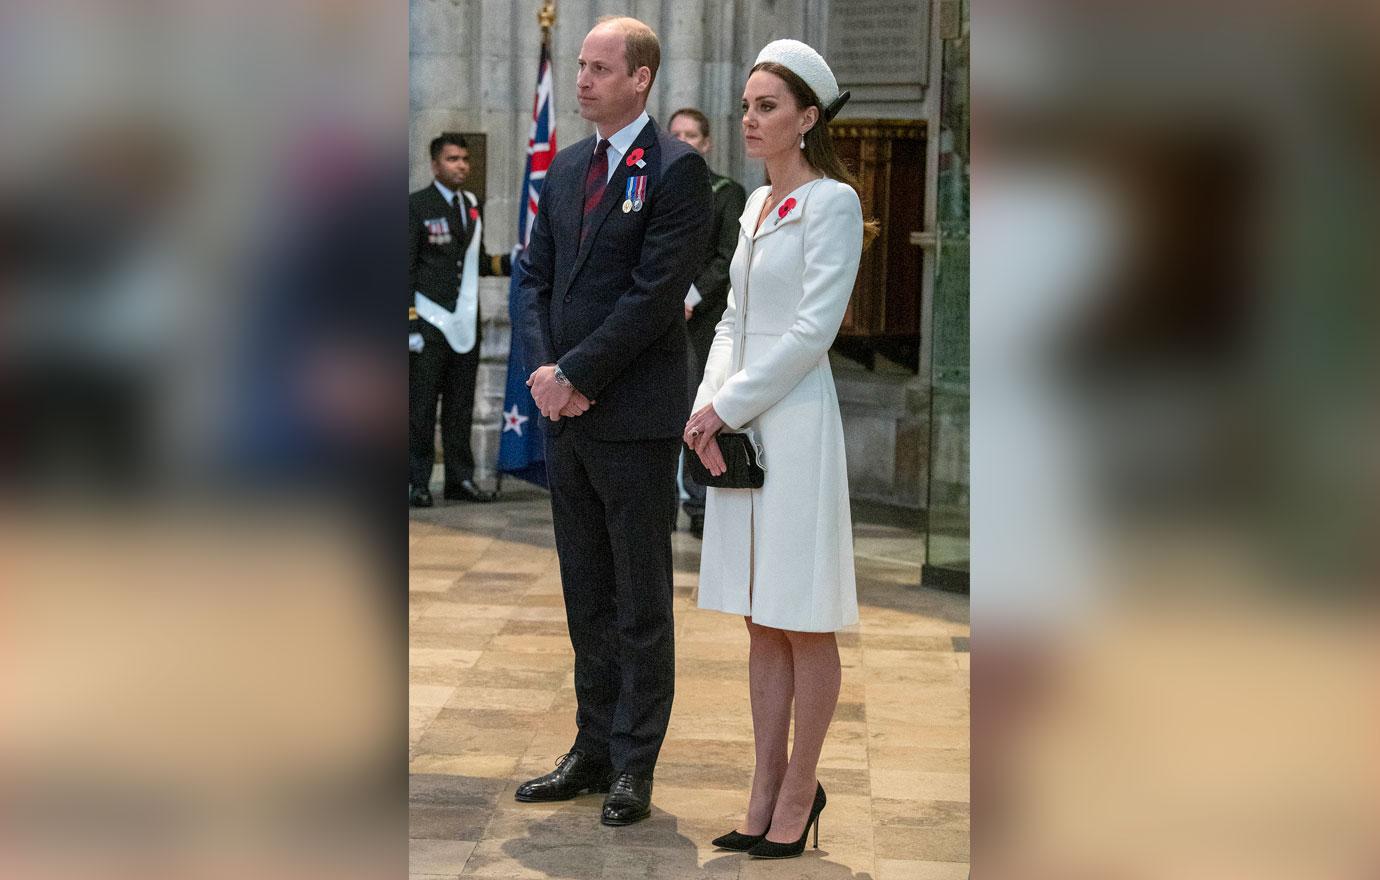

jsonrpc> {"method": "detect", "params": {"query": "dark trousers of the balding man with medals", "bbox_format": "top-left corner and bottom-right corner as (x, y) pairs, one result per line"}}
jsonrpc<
(546, 430), (679, 775)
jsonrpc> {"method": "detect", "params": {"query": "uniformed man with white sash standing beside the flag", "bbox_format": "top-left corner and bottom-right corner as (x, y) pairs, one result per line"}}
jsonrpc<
(407, 134), (512, 508)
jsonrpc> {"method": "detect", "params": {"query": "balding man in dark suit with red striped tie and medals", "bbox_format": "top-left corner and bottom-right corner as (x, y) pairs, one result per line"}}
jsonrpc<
(515, 18), (712, 825)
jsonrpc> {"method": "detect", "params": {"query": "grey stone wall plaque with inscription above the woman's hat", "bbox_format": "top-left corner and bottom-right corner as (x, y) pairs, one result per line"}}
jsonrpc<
(825, 0), (930, 88)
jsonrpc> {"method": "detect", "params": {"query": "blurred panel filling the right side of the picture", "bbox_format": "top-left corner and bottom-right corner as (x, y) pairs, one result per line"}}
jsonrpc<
(972, 3), (1380, 880)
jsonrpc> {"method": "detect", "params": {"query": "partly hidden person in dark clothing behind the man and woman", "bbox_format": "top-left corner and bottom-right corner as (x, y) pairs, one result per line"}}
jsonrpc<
(667, 108), (748, 538)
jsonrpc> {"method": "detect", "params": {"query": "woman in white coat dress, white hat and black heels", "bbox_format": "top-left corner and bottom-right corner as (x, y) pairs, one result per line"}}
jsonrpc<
(684, 40), (875, 858)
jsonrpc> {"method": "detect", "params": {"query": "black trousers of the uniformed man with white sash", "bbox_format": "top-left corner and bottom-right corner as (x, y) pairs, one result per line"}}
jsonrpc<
(407, 321), (479, 488)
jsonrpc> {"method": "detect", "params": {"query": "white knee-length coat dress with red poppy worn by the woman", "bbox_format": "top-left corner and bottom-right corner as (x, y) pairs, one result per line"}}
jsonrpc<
(694, 178), (863, 632)
